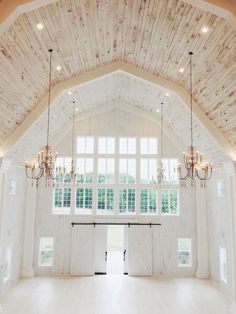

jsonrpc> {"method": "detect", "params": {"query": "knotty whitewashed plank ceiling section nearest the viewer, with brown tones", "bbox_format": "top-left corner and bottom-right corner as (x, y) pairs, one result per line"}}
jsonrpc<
(0, 0), (236, 162)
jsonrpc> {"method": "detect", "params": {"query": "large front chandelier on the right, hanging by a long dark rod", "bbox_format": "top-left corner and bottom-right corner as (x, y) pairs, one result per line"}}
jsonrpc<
(177, 51), (212, 187)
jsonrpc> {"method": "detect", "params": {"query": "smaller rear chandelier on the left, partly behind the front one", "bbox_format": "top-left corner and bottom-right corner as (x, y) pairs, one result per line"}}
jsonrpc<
(56, 101), (77, 186)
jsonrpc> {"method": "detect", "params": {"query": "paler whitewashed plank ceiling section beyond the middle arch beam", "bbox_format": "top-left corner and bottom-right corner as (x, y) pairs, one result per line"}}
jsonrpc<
(7, 71), (230, 165)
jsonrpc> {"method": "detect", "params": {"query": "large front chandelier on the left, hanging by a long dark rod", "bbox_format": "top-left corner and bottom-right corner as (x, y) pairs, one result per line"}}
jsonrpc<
(25, 49), (57, 187)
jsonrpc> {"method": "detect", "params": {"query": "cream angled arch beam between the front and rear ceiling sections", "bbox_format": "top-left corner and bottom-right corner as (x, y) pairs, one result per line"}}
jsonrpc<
(0, 62), (236, 160)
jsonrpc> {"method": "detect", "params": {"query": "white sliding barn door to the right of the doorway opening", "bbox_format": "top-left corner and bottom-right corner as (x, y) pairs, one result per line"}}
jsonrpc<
(128, 226), (152, 276)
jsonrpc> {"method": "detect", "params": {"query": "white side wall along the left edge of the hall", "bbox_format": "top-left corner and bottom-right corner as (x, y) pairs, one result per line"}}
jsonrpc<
(0, 166), (25, 294)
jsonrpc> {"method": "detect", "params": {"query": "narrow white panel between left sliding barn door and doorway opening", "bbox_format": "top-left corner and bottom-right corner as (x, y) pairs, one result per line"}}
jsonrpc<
(94, 225), (107, 274)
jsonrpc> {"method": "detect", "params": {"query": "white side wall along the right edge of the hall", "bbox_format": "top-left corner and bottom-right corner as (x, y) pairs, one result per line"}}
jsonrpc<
(207, 168), (235, 293)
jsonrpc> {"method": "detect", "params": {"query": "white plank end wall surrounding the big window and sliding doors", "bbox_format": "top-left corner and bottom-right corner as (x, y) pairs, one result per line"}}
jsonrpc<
(34, 109), (197, 276)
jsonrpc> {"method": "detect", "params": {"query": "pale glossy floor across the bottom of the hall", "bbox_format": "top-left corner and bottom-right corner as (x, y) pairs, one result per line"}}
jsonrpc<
(0, 275), (229, 314)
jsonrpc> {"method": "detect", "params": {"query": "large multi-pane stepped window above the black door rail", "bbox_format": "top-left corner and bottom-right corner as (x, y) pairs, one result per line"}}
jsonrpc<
(53, 136), (179, 215)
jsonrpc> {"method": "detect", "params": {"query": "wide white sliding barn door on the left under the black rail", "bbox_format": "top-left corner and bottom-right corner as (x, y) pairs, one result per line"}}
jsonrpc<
(71, 225), (95, 275)
